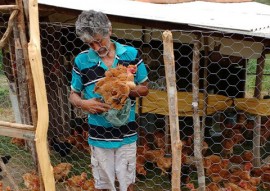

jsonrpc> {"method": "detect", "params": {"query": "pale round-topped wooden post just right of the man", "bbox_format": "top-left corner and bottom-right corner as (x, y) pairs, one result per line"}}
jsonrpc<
(162, 31), (182, 191)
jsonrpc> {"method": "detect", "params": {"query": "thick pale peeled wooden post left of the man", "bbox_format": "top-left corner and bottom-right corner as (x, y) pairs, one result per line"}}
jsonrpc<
(28, 0), (55, 191)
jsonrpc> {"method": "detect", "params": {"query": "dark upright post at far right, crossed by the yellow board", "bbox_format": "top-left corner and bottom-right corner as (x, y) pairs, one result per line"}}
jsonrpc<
(253, 50), (265, 167)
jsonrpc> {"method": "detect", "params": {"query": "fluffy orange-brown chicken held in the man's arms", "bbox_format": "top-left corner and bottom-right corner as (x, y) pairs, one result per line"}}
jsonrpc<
(94, 65), (137, 110)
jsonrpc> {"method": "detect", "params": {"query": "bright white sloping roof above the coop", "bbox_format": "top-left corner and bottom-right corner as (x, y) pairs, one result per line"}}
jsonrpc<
(39, 0), (270, 38)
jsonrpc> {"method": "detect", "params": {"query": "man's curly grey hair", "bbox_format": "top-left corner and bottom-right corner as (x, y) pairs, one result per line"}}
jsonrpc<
(75, 10), (111, 42)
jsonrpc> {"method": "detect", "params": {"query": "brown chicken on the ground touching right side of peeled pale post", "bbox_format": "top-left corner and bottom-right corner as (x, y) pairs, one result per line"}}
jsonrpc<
(53, 163), (73, 182)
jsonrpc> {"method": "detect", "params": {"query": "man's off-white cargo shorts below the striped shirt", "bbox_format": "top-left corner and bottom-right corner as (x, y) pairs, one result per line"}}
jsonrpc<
(91, 142), (137, 191)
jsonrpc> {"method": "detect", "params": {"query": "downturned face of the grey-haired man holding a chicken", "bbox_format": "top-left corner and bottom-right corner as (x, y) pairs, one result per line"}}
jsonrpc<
(88, 34), (111, 58)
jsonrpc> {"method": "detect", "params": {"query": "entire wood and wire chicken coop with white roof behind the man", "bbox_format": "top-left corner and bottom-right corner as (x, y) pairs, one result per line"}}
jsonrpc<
(0, 0), (270, 191)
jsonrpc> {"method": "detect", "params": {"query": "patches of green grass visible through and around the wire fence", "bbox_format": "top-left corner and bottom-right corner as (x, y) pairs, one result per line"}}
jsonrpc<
(0, 56), (270, 191)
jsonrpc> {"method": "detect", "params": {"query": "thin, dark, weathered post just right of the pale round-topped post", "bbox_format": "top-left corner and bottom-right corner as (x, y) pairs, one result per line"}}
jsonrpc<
(192, 37), (205, 191)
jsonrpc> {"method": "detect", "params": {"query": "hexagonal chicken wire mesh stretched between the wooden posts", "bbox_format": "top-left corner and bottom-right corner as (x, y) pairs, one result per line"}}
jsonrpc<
(0, 13), (270, 191)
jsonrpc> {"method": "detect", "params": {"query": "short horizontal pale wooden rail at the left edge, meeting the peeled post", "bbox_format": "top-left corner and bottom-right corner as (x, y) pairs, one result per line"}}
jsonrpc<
(0, 125), (35, 141)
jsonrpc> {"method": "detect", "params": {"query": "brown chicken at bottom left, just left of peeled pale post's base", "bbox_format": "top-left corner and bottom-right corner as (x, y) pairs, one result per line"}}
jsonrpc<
(22, 172), (40, 191)
